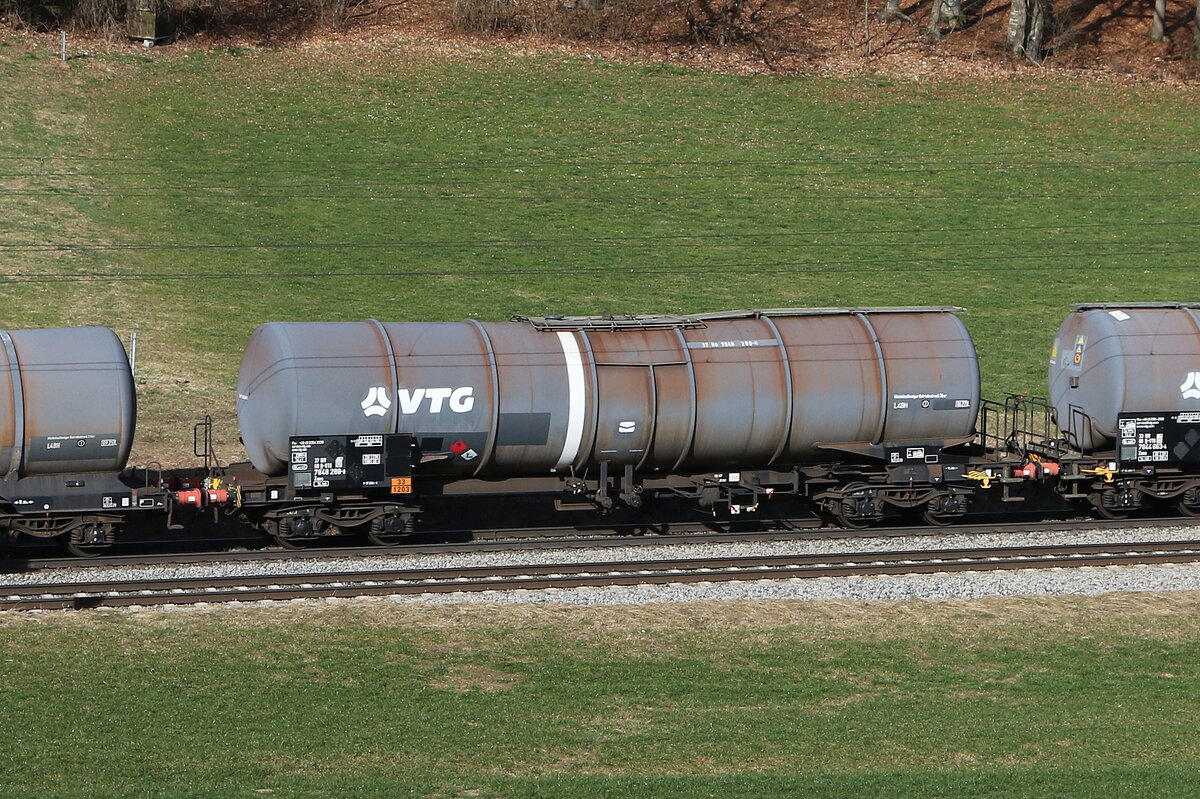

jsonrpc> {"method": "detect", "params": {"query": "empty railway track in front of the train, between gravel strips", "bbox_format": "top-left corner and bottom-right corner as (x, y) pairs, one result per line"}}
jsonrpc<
(9, 541), (1200, 611)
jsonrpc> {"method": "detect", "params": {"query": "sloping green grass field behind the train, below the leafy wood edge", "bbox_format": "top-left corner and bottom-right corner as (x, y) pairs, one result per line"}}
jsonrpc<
(0, 34), (1200, 455)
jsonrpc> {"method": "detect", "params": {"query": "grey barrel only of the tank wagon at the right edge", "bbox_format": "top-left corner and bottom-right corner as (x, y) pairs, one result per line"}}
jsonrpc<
(1048, 302), (1200, 452)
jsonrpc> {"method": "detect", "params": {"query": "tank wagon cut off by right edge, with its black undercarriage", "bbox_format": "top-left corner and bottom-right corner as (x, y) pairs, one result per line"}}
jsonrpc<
(1048, 302), (1200, 517)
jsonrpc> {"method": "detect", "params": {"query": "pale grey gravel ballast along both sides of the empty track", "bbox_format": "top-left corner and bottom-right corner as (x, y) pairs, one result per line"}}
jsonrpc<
(7, 525), (1200, 605)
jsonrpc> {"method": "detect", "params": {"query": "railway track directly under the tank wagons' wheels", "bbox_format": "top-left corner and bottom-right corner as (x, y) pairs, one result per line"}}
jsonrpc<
(0, 517), (1194, 573)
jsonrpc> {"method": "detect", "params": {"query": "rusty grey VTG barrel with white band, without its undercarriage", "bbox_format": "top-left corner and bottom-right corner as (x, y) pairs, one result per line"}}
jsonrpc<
(238, 308), (979, 477)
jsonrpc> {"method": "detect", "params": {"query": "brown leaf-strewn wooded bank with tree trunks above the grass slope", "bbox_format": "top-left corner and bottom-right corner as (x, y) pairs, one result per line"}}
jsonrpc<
(7, 0), (1200, 82)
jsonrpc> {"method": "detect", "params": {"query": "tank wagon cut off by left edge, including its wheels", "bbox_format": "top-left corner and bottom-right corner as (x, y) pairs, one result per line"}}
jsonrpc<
(0, 328), (166, 553)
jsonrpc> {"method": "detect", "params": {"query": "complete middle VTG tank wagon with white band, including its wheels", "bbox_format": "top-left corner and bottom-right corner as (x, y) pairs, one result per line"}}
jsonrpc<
(229, 307), (979, 540)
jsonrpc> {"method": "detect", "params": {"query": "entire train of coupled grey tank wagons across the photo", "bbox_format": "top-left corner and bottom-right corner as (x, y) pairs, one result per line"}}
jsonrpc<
(11, 298), (1200, 554)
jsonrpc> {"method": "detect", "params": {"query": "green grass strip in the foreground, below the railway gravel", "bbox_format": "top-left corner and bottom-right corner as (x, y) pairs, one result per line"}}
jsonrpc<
(0, 597), (1200, 797)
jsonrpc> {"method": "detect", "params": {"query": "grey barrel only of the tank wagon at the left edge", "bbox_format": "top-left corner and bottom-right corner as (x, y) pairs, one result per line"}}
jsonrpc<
(0, 328), (137, 479)
